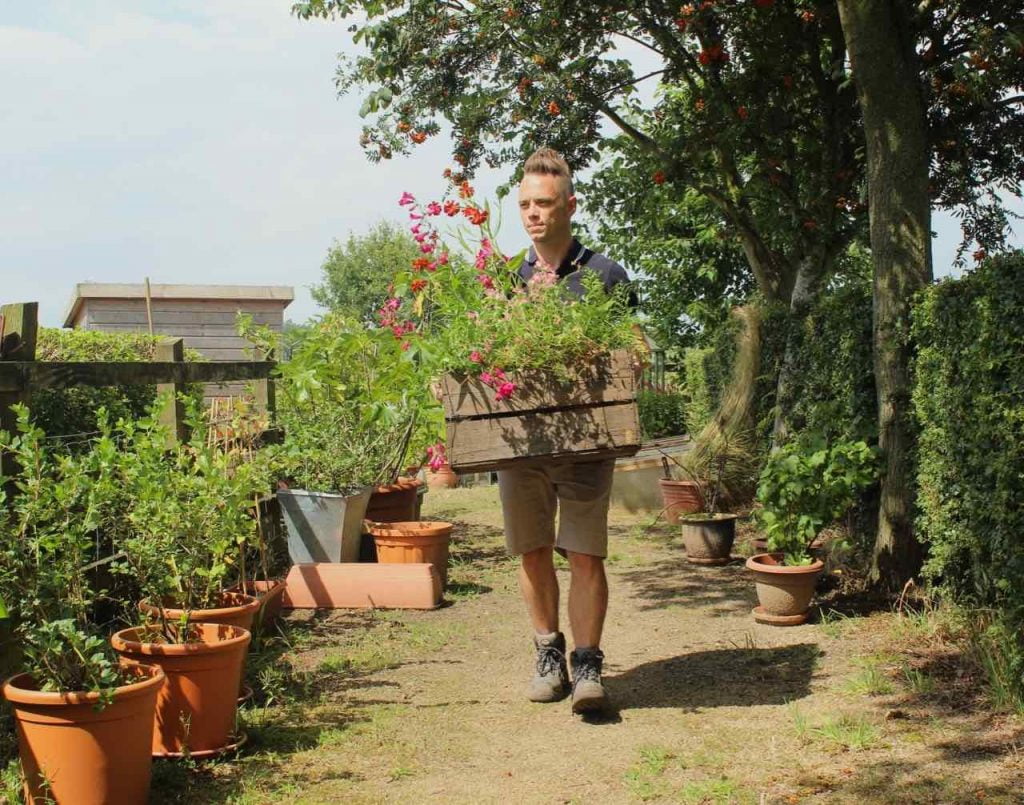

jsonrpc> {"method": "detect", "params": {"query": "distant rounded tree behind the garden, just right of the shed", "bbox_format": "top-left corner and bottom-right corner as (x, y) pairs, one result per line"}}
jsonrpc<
(310, 221), (420, 325)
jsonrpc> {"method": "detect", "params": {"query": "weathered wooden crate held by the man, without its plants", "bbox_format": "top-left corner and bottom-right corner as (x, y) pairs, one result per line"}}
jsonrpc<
(441, 350), (640, 472)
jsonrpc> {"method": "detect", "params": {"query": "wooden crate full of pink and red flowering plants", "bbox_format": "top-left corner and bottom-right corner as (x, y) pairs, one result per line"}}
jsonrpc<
(389, 189), (640, 471)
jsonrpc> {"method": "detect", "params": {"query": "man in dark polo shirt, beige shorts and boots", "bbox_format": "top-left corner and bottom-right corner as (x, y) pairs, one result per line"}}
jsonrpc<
(498, 149), (629, 713)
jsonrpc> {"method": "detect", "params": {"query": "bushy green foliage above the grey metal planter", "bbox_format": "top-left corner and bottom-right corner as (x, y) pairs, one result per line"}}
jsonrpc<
(243, 313), (443, 492)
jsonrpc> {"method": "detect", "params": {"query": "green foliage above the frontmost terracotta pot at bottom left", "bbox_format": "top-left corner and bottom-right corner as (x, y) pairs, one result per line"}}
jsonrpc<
(0, 406), (120, 701)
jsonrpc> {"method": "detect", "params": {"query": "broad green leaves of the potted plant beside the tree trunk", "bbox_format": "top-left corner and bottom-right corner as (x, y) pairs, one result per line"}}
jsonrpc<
(758, 434), (878, 565)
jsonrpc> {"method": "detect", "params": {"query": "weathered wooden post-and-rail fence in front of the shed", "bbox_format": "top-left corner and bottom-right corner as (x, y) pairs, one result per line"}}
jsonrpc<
(0, 302), (276, 475)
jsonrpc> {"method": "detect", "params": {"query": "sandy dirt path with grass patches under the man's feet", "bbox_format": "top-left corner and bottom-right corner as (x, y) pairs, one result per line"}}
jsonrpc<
(154, 488), (1024, 805)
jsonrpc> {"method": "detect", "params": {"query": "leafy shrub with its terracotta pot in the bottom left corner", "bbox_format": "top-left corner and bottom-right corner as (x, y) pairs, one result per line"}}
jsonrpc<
(0, 408), (165, 805)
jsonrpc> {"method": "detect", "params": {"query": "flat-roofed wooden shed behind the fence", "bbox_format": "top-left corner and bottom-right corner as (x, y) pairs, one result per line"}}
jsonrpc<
(65, 283), (295, 361)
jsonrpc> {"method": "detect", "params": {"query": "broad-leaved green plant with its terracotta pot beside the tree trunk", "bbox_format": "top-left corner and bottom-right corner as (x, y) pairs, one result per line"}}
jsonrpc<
(746, 435), (877, 626)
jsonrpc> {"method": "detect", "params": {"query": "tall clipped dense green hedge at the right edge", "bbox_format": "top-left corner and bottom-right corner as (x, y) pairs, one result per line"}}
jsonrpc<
(913, 247), (1024, 610)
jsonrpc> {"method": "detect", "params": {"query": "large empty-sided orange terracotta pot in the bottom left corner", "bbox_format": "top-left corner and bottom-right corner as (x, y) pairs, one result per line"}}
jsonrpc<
(3, 665), (165, 805)
